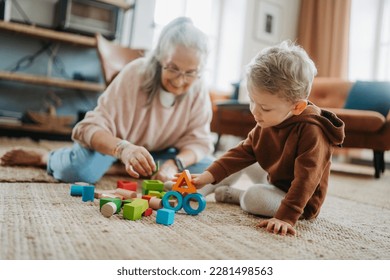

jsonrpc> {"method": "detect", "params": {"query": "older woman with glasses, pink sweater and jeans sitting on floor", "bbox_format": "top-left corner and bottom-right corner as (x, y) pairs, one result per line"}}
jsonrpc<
(1, 18), (213, 183)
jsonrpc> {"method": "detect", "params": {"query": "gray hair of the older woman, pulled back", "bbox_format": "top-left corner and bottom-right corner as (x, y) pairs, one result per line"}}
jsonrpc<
(142, 17), (209, 103)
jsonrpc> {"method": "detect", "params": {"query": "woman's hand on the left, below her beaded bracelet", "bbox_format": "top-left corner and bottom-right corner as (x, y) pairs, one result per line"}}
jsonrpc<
(120, 143), (156, 178)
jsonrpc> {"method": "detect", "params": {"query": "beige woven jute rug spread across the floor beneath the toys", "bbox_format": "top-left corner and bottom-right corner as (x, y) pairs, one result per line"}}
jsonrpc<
(0, 138), (390, 260)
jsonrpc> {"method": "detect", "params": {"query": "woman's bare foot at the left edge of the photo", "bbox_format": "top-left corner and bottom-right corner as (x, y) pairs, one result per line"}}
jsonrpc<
(1, 149), (49, 167)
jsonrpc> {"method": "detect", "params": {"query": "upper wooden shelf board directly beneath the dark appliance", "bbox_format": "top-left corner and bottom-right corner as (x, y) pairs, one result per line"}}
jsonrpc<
(0, 20), (96, 48)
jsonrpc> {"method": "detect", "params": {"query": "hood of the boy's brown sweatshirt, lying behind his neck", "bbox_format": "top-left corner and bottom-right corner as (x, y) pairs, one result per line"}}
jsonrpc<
(275, 102), (345, 146)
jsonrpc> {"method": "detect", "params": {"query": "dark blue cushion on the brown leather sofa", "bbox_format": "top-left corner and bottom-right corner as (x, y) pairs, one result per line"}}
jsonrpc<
(344, 81), (390, 117)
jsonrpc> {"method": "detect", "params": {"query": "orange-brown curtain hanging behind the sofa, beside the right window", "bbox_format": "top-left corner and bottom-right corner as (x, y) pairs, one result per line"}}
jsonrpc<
(298, 0), (351, 78)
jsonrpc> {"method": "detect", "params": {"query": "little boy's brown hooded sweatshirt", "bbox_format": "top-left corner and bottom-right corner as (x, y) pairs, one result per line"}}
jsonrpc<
(207, 102), (345, 225)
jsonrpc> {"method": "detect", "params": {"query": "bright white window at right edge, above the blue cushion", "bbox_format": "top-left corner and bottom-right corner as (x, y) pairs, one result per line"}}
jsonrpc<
(349, 0), (390, 81)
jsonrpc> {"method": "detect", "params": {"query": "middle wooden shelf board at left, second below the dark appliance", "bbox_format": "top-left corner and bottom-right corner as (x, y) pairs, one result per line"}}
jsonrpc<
(0, 70), (105, 92)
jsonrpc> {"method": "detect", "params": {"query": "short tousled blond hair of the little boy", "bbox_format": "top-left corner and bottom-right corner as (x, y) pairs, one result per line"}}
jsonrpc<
(246, 40), (317, 103)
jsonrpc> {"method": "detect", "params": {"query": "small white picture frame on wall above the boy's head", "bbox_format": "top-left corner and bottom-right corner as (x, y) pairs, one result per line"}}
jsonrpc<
(255, 0), (282, 44)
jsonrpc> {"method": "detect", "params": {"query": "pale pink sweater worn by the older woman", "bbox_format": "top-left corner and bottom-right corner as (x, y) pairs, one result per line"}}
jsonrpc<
(72, 58), (213, 160)
